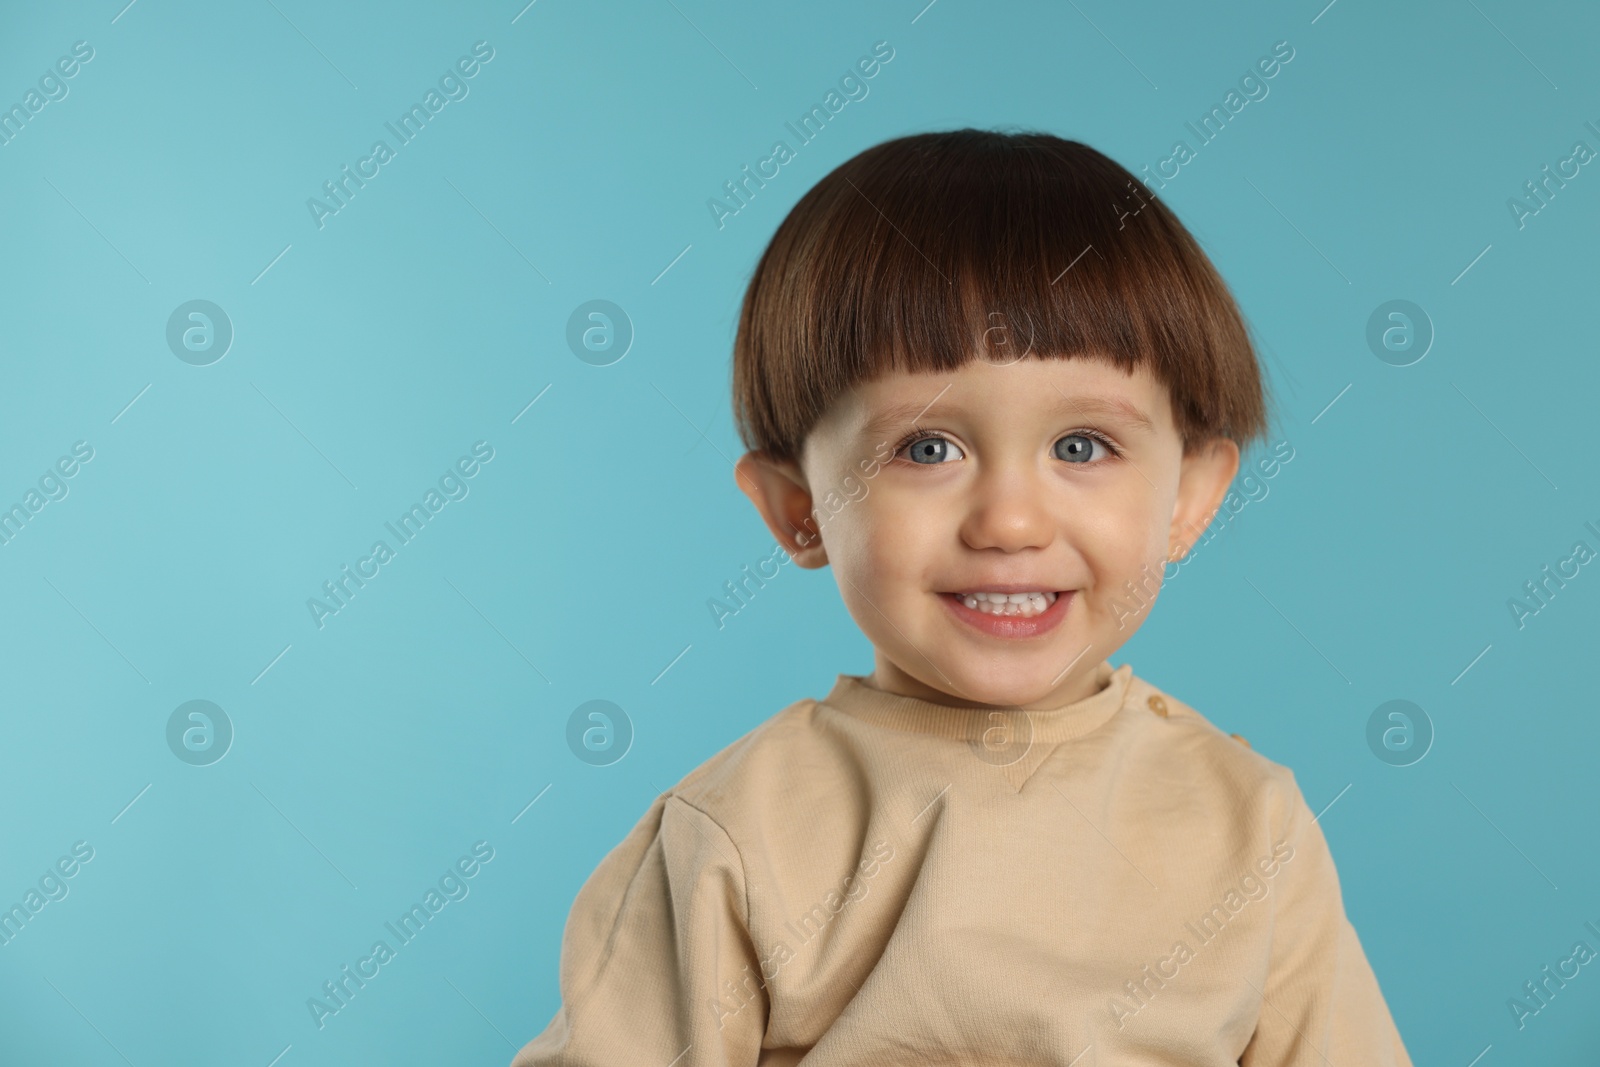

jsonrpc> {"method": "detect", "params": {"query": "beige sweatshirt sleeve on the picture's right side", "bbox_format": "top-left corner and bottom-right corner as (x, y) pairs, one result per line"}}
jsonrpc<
(1238, 773), (1411, 1067)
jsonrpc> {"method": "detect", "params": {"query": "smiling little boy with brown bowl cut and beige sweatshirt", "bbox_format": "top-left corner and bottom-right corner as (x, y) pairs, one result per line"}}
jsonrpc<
(514, 130), (1411, 1067)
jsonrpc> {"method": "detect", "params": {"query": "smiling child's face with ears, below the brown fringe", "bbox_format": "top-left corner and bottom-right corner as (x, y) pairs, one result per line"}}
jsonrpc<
(736, 358), (1238, 707)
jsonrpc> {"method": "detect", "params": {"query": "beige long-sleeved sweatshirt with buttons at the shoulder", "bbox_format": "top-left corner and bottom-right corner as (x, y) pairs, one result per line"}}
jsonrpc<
(512, 662), (1411, 1067)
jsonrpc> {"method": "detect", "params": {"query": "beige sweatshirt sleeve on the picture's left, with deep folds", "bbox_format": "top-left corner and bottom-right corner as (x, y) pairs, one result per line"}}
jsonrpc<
(512, 793), (766, 1067)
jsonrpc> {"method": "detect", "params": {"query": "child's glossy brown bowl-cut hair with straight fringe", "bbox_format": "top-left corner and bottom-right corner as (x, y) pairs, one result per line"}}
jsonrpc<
(733, 128), (1267, 461)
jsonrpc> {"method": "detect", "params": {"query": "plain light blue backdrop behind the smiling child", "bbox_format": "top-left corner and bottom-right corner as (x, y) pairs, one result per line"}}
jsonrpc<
(0, 0), (1600, 1067)
